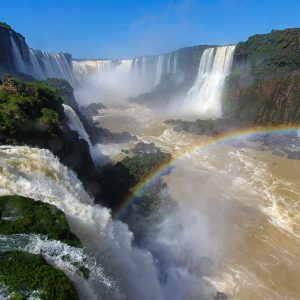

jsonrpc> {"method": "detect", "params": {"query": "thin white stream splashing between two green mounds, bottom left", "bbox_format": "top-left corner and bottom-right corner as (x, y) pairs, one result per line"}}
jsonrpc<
(0, 234), (109, 300)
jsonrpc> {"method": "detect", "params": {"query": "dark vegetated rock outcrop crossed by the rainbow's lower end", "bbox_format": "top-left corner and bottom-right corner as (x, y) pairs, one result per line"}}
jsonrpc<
(96, 151), (175, 243)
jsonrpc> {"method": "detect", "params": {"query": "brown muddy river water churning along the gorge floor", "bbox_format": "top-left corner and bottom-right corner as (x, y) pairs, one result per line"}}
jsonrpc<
(97, 107), (300, 300)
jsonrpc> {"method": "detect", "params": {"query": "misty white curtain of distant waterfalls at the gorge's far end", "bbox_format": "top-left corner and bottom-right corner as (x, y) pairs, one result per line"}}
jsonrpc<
(73, 46), (235, 119)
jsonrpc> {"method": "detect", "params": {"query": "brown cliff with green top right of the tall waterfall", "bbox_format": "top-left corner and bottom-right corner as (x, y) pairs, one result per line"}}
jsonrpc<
(223, 28), (300, 124)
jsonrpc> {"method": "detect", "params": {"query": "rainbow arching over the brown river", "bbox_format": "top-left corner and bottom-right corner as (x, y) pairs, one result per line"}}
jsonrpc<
(114, 125), (300, 218)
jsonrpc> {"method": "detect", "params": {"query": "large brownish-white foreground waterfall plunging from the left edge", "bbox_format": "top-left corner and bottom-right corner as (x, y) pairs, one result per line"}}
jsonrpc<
(0, 146), (163, 300)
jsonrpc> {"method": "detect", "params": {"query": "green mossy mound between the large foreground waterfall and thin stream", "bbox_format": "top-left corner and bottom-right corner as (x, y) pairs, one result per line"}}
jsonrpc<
(0, 195), (81, 247)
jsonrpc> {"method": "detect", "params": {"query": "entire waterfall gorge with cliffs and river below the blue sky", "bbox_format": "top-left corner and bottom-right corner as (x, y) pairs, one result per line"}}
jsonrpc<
(0, 19), (300, 300)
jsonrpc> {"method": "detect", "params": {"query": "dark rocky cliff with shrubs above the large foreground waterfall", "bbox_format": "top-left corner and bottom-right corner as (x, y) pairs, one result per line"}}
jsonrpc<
(0, 78), (94, 181)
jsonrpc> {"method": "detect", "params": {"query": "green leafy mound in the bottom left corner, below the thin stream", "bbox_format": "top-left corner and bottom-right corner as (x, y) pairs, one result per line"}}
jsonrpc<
(0, 251), (78, 300)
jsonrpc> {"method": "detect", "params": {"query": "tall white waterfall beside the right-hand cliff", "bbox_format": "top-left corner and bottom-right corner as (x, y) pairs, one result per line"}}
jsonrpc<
(185, 46), (235, 118)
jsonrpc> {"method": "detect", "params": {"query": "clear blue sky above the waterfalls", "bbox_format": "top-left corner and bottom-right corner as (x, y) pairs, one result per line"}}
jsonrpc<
(0, 0), (300, 58)
